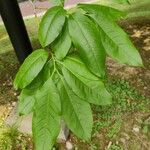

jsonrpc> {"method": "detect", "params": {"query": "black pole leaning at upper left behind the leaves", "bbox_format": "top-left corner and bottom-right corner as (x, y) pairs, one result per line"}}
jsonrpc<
(0, 0), (32, 63)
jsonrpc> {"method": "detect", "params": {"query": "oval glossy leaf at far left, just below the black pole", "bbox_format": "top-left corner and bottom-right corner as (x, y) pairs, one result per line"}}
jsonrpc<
(14, 49), (49, 89)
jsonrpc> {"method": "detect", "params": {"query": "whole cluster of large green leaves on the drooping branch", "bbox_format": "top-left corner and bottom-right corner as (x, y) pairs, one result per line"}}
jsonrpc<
(14, 1), (142, 150)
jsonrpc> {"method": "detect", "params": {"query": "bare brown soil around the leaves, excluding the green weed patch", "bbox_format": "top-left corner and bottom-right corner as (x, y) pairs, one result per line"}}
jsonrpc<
(0, 21), (150, 150)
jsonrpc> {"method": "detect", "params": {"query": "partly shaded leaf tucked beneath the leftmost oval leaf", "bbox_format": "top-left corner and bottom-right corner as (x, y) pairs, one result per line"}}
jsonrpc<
(18, 59), (57, 115)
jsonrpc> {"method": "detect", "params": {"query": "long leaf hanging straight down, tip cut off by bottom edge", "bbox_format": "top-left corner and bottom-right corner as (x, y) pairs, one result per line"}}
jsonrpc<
(32, 78), (61, 150)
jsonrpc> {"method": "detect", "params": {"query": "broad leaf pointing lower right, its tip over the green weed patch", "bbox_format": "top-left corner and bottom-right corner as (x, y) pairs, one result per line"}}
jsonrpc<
(63, 57), (112, 105)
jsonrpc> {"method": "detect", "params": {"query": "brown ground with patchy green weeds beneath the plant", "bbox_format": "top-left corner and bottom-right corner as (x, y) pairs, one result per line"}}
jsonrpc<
(0, 19), (150, 150)
